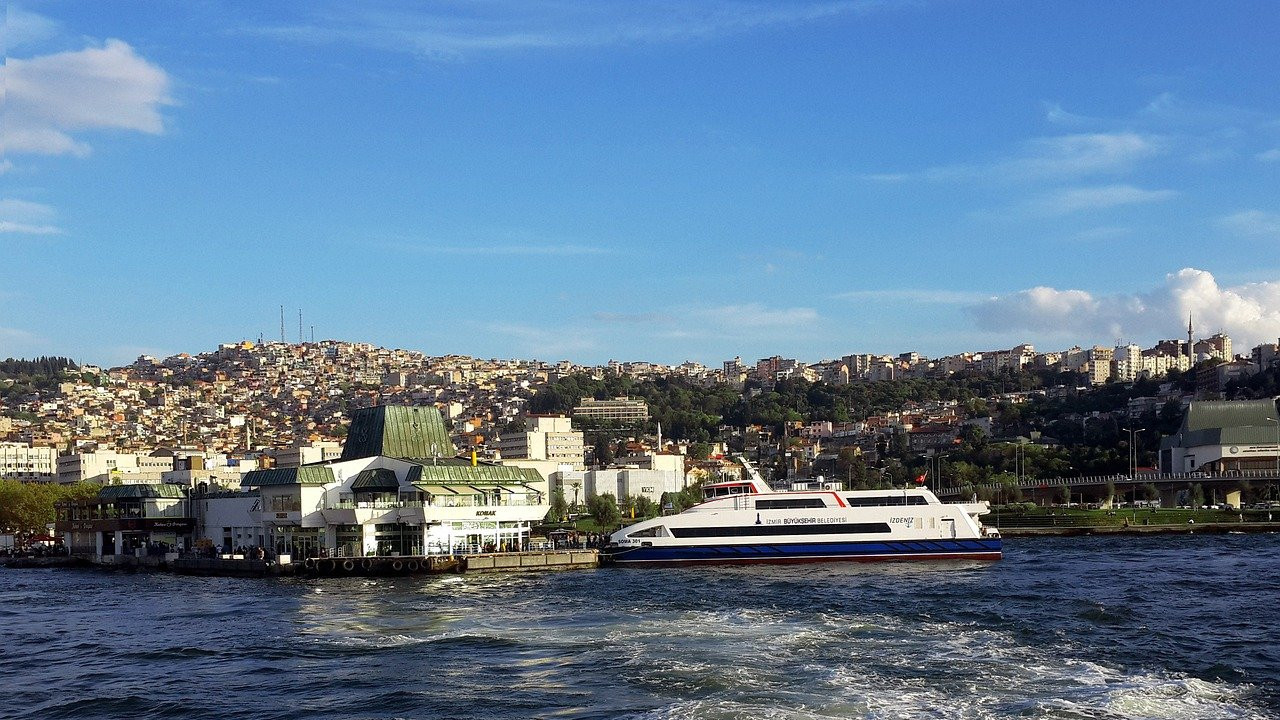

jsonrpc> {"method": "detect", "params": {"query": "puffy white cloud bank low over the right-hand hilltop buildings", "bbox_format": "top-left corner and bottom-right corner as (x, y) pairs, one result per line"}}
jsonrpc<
(968, 268), (1280, 348)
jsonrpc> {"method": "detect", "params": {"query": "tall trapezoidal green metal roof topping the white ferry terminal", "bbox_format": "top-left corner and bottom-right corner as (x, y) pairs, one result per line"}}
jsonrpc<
(342, 405), (457, 460)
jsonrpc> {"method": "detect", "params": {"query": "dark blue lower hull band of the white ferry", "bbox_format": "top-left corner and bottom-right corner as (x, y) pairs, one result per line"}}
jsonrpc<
(604, 538), (1001, 564)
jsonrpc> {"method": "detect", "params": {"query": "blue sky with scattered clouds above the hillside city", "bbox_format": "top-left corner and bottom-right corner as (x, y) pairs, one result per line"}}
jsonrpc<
(0, 0), (1280, 364)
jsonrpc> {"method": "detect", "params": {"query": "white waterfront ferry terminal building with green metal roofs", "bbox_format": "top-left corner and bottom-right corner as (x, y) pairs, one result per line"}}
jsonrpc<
(192, 406), (549, 560)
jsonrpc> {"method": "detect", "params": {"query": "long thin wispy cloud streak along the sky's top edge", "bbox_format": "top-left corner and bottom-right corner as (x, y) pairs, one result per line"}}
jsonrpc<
(246, 0), (890, 59)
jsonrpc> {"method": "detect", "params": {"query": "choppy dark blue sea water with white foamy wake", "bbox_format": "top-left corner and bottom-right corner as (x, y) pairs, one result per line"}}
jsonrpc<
(0, 536), (1280, 720)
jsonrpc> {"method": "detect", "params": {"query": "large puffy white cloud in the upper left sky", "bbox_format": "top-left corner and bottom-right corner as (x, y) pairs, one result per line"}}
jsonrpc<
(0, 40), (173, 156)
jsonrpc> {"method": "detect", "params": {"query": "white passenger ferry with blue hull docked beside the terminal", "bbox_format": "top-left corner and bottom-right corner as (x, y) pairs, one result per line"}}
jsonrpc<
(602, 462), (1001, 565)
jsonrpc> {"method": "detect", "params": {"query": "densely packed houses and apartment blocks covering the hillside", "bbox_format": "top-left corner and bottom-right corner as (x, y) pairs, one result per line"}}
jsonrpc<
(0, 324), (1277, 487)
